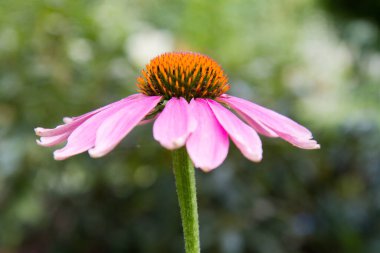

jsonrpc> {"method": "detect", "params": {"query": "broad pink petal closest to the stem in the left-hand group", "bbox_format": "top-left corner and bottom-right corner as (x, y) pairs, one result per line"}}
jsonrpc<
(89, 96), (161, 157)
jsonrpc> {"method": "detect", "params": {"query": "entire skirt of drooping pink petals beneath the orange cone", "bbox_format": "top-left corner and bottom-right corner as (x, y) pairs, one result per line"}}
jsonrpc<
(35, 94), (320, 171)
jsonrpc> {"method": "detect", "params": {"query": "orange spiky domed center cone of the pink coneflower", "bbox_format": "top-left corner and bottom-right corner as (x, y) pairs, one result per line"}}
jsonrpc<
(137, 52), (230, 101)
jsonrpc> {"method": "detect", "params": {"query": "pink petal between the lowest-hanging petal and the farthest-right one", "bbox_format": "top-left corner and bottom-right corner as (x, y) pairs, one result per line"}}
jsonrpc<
(207, 99), (263, 162)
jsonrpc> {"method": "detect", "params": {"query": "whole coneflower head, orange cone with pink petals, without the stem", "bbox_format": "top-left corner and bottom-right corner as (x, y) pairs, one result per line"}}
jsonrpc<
(35, 52), (320, 171)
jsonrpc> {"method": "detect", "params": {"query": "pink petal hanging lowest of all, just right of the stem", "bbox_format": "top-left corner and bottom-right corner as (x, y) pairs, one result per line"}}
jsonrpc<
(186, 98), (229, 171)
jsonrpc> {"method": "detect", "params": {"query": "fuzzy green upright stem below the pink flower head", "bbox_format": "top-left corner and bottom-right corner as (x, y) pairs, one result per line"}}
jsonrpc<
(172, 148), (200, 253)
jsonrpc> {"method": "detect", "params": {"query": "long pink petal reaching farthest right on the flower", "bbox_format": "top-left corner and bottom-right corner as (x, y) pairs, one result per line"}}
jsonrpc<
(219, 96), (320, 149)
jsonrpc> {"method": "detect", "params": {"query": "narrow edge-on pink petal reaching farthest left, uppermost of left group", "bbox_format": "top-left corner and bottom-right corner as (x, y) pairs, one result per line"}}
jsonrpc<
(34, 94), (143, 137)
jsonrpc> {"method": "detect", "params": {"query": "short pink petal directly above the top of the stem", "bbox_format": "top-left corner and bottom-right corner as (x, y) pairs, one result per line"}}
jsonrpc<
(153, 97), (196, 150)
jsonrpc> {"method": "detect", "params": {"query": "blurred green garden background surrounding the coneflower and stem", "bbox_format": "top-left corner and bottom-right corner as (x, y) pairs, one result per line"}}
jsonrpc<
(0, 0), (380, 253)
